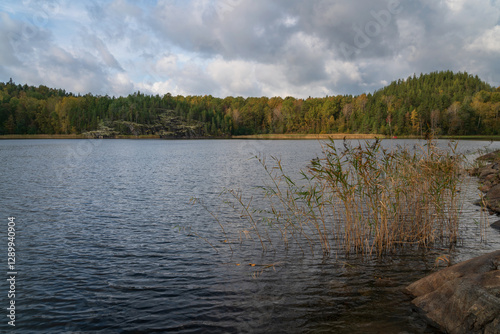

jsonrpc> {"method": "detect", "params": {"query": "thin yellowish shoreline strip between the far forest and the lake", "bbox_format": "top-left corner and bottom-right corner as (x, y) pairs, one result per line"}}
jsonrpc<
(0, 133), (500, 141)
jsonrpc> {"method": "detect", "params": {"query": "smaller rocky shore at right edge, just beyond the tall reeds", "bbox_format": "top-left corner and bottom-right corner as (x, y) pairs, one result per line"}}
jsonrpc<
(471, 151), (500, 214)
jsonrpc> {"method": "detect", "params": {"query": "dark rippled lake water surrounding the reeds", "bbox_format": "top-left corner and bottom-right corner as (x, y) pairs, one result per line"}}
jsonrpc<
(0, 140), (500, 333)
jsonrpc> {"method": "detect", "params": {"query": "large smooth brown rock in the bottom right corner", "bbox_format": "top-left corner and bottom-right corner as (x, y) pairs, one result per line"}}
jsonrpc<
(406, 250), (500, 334)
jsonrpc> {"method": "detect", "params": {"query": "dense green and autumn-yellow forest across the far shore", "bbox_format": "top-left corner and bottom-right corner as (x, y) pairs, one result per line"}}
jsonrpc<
(0, 71), (500, 137)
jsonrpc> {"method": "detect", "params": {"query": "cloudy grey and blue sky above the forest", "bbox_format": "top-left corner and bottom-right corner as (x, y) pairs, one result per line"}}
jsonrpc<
(0, 0), (500, 98)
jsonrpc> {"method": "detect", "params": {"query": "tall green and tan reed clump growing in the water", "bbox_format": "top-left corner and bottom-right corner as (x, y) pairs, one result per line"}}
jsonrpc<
(207, 140), (464, 256)
